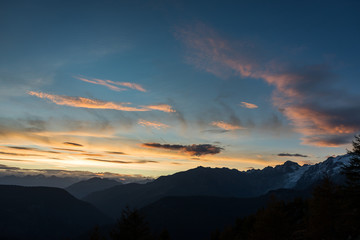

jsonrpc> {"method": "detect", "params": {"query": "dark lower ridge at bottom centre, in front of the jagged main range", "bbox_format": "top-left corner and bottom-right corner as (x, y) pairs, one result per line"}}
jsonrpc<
(140, 189), (310, 240)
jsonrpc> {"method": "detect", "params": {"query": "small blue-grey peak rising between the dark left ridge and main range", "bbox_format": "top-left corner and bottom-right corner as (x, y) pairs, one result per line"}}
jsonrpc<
(66, 177), (122, 198)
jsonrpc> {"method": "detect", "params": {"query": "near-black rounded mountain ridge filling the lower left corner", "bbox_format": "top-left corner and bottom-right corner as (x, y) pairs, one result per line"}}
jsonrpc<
(0, 185), (111, 240)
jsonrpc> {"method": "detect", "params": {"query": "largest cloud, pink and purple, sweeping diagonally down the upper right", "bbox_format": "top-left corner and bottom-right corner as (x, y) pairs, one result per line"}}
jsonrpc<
(177, 23), (360, 147)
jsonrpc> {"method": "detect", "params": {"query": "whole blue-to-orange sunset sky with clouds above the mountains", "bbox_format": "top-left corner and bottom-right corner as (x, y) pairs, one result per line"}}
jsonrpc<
(0, 0), (360, 177)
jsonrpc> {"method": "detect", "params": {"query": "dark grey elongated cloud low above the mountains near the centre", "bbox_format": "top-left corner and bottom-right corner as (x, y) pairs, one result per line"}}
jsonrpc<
(143, 143), (224, 156)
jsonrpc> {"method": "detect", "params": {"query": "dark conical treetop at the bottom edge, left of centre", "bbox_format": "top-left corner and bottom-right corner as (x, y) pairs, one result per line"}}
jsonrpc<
(110, 207), (154, 240)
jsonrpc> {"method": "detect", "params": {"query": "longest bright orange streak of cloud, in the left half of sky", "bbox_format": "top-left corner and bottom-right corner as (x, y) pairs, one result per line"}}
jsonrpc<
(28, 91), (175, 113)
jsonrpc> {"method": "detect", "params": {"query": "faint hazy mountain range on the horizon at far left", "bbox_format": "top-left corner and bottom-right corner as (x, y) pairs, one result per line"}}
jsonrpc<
(0, 174), (80, 188)
